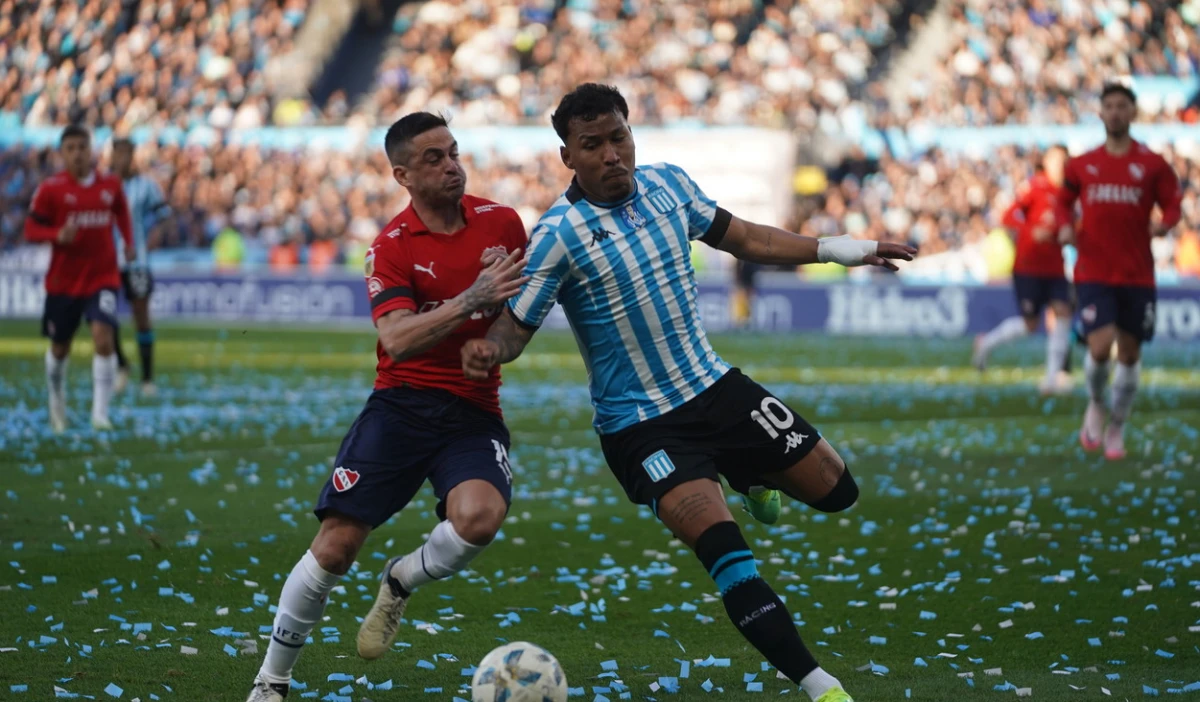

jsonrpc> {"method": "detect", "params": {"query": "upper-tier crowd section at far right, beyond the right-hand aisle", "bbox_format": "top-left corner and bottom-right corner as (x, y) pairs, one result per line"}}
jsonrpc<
(892, 0), (1200, 126)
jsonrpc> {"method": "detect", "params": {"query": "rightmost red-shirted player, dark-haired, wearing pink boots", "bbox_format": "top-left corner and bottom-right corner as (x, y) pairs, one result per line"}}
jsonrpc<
(1061, 84), (1183, 460)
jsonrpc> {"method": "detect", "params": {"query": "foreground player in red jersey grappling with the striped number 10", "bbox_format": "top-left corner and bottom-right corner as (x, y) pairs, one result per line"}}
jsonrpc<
(247, 113), (529, 702)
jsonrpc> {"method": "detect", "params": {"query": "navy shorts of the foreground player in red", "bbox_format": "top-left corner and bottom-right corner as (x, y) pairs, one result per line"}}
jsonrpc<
(313, 388), (512, 527)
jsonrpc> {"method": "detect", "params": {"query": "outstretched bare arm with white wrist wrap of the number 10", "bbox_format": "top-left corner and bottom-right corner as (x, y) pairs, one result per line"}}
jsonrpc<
(716, 217), (917, 270)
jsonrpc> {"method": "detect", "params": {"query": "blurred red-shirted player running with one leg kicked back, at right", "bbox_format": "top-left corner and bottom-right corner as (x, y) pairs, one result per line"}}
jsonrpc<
(972, 146), (1073, 395)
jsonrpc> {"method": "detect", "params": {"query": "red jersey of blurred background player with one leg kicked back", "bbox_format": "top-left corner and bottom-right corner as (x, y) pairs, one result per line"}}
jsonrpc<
(1004, 173), (1067, 278)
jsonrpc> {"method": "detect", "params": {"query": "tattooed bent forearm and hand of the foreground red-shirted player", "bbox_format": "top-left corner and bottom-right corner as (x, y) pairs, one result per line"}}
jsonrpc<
(376, 250), (529, 362)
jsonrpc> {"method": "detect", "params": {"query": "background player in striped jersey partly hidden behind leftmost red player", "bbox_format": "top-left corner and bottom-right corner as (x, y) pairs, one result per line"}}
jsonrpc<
(113, 139), (170, 397)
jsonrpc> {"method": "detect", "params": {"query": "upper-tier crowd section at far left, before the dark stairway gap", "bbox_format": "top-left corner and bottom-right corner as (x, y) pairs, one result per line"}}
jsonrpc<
(0, 0), (308, 130)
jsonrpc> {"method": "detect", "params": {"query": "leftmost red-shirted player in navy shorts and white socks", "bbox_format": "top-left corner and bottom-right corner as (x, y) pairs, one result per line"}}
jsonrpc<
(25, 125), (137, 433)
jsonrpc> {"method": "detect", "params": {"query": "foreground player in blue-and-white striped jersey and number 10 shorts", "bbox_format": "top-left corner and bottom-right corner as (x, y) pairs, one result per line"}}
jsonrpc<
(462, 84), (916, 702)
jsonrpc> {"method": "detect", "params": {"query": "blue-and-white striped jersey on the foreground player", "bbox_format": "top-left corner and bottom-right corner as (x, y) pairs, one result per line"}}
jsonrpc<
(509, 163), (731, 434)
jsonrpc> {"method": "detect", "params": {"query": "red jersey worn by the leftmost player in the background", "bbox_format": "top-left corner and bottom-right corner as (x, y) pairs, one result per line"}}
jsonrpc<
(25, 172), (133, 298)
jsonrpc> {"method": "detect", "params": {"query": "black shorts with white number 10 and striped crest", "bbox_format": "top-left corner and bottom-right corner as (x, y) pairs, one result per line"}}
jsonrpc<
(600, 368), (821, 509)
